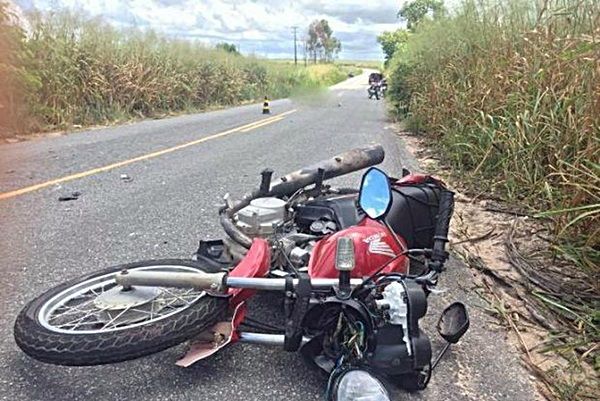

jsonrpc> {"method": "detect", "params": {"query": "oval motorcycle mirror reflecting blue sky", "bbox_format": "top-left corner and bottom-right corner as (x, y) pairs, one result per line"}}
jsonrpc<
(358, 168), (392, 219)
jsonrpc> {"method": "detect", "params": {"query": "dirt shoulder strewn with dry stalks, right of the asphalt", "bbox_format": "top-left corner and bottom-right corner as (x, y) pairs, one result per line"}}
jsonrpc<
(396, 126), (600, 400)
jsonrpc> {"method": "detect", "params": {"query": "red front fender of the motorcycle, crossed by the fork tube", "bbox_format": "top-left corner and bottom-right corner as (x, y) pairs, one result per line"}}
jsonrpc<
(229, 238), (271, 310)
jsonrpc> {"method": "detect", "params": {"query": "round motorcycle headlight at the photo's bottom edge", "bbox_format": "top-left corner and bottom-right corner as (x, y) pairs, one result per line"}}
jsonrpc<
(335, 370), (390, 401)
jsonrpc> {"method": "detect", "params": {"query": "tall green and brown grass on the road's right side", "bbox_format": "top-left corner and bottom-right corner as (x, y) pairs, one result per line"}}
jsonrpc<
(380, 0), (600, 399)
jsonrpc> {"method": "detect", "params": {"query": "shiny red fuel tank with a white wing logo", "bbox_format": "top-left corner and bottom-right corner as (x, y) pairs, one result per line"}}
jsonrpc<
(308, 218), (408, 278)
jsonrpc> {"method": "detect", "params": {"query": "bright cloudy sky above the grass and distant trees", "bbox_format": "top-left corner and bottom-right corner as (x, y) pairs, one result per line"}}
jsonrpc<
(14, 0), (403, 60)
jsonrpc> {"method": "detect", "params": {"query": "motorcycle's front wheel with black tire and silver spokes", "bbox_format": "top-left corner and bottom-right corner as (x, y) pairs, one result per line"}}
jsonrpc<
(14, 259), (228, 366)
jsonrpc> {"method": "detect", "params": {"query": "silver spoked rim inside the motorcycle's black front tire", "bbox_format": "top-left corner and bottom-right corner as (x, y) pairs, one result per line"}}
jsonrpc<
(37, 265), (205, 334)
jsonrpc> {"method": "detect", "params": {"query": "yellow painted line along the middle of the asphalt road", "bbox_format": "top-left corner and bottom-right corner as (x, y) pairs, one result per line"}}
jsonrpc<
(0, 109), (297, 200)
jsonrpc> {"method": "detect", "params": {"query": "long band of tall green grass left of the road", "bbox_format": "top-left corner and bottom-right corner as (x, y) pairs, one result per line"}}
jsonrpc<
(0, 6), (346, 132)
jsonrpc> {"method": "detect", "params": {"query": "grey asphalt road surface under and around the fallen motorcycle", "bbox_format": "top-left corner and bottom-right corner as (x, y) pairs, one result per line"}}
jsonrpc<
(0, 72), (536, 401)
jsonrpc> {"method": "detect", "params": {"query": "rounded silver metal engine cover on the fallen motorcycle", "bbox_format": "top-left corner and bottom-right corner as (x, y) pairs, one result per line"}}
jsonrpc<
(235, 198), (286, 236)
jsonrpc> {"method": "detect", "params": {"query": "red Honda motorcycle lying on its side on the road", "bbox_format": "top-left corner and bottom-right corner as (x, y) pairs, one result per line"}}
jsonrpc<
(14, 145), (469, 401)
